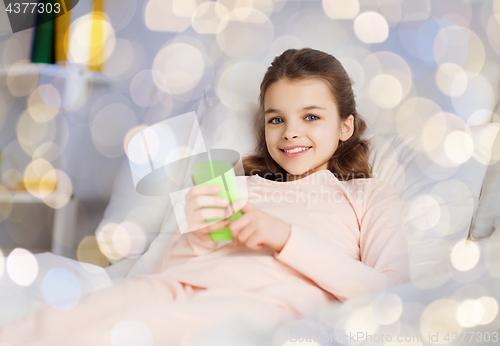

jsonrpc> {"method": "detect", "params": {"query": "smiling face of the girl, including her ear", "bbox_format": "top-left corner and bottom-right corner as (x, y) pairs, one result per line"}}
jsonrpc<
(264, 78), (354, 180)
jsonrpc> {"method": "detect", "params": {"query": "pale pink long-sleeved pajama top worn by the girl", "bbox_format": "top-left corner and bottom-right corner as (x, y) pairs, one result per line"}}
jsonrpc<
(157, 170), (410, 315)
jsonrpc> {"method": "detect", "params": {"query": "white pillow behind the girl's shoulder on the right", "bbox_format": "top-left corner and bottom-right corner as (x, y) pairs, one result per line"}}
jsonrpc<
(370, 124), (498, 288)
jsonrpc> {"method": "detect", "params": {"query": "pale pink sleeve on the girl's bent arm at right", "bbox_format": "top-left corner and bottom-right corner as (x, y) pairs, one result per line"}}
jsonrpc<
(274, 182), (410, 301)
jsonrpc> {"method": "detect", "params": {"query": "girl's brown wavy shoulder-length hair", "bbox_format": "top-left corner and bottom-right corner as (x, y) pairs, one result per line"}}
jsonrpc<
(242, 48), (372, 181)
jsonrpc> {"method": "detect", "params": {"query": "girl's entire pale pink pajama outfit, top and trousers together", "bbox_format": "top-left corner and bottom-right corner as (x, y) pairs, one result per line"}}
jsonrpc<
(0, 170), (409, 346)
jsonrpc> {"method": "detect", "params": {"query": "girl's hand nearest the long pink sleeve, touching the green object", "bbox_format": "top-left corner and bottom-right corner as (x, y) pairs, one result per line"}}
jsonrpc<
(229, 202), (292, 252)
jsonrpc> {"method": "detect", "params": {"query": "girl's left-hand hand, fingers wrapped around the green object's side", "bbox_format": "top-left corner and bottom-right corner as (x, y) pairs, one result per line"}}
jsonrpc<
(184, 185), (231, 241)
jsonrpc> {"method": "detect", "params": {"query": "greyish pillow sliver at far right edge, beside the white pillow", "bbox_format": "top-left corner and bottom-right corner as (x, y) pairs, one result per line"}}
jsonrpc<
(470, 123), (500, 239)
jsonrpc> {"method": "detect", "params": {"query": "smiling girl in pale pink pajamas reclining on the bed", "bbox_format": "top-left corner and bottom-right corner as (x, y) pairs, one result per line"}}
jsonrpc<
(0, 48), (409, 345)
